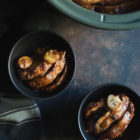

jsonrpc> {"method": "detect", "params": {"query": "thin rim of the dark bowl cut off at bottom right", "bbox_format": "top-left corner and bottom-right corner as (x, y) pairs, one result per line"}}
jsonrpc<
(78, 83), (140, 140)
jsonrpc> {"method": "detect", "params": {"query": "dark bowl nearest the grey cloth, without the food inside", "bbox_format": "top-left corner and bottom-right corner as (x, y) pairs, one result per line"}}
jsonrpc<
(8, 31), (75, 99)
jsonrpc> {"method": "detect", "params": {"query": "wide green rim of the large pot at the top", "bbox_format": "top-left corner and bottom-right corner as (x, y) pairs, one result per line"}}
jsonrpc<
(47, 0), (140, 30)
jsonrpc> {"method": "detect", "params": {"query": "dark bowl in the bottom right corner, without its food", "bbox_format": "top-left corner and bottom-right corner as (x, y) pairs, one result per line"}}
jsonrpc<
(78, 84), (140, 140)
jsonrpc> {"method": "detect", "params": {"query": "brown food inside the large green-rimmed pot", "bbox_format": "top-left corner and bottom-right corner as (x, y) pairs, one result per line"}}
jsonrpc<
(73, 0), (140, 14)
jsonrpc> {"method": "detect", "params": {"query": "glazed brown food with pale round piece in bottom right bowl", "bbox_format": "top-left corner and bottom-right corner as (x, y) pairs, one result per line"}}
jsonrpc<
(84, 94), (135, 140)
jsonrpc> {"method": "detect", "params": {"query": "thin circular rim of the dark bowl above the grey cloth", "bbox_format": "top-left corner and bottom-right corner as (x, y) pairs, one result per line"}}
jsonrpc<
(8, 30), (76, 100)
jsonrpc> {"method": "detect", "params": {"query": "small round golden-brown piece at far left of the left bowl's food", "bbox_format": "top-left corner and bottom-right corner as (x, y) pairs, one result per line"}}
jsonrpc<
(18, 56), (33, 69)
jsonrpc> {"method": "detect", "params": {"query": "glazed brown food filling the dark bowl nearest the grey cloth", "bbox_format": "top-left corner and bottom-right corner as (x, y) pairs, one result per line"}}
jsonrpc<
(16, 48), (67, 92)
